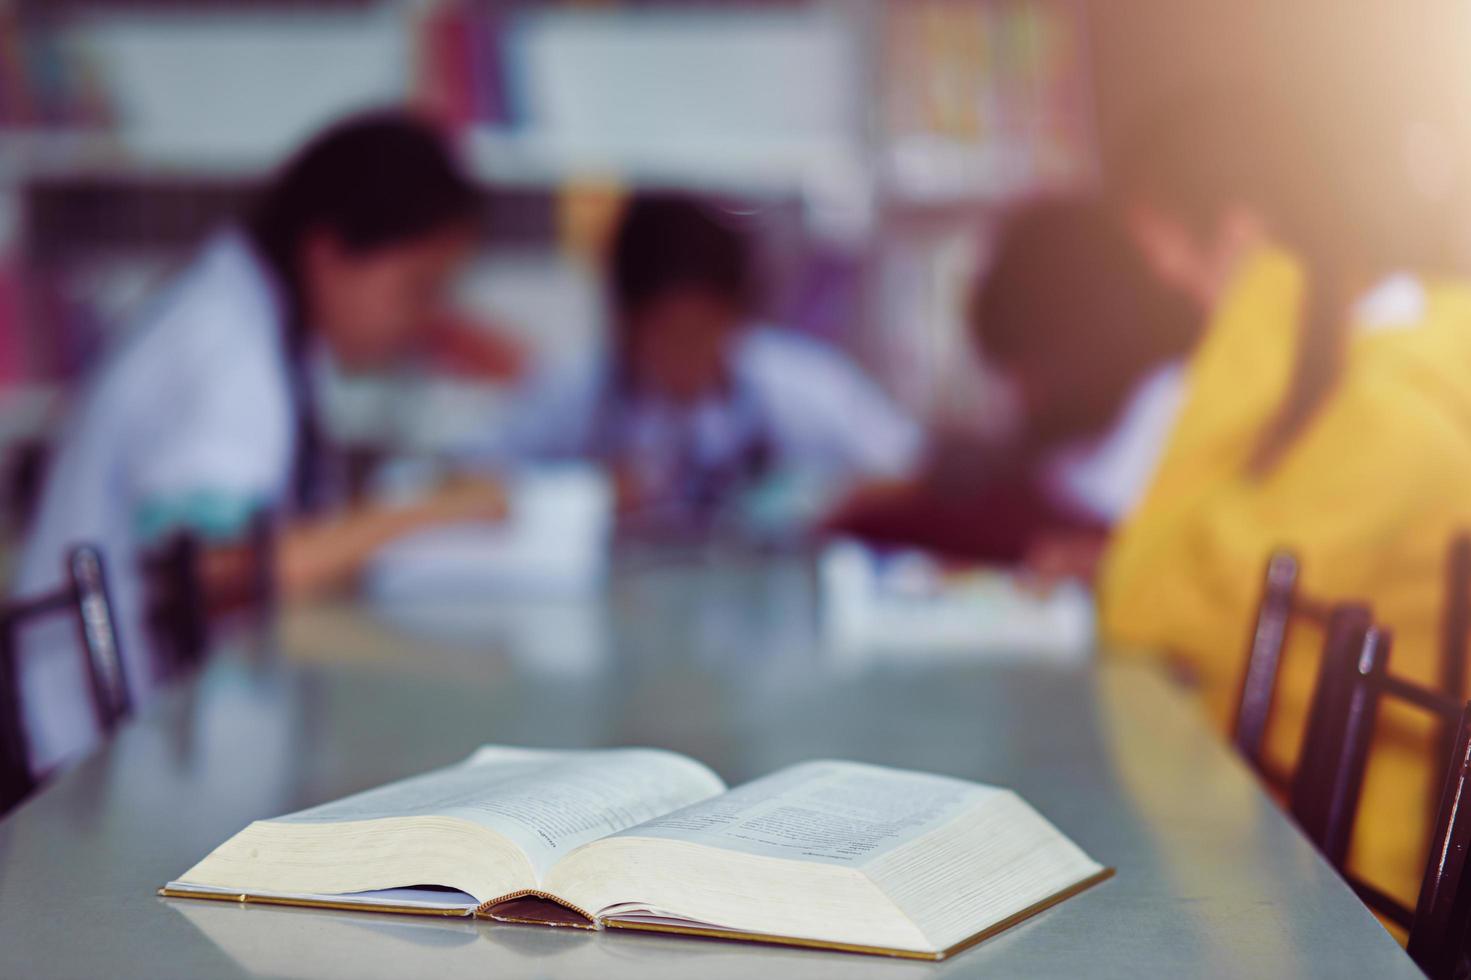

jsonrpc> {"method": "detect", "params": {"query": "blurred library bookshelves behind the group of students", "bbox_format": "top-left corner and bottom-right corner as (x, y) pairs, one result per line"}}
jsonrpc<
(0, 0), (1471, 527)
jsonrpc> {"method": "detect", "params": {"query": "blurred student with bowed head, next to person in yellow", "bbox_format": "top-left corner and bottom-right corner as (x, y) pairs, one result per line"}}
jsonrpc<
(831, 200), (1202, 565)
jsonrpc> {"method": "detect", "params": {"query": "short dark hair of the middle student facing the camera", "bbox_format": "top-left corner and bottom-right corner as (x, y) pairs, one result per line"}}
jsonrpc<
(610, 193), (752, 313)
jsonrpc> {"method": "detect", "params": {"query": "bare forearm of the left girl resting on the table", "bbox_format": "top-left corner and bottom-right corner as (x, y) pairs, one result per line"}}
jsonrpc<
(275, 478), (507, 602)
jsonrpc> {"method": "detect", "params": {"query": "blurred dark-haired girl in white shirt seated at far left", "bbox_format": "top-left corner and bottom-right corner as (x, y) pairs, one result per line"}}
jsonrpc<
(16, 112), (503, 775)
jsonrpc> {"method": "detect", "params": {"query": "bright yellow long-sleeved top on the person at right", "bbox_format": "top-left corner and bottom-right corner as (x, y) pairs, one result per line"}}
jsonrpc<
(1099, 250), (1471, 902)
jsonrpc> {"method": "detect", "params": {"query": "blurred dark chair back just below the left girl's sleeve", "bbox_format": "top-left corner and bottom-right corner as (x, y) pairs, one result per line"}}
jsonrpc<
(143, 512), (275, 677)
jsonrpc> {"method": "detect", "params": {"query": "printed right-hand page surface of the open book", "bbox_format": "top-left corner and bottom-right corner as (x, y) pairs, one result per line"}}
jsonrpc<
(621, 761), (1005, 865)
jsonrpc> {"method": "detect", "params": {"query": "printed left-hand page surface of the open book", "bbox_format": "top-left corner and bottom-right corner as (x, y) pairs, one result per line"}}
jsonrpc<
(274, 746), (725, 878)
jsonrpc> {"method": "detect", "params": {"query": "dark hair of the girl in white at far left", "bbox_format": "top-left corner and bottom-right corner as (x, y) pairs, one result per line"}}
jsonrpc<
(249, 109), (480, 326)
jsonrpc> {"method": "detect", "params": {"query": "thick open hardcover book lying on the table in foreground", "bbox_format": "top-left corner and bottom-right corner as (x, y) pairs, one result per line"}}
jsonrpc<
(162, 746), (1111, 959)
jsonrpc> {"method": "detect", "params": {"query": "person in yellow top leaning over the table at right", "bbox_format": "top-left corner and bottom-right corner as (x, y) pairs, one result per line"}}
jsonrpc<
(1097, 103), (1471, 902)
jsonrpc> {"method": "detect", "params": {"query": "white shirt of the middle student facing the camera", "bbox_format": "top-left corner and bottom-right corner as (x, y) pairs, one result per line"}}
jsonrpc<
(499, 325), (924, 497)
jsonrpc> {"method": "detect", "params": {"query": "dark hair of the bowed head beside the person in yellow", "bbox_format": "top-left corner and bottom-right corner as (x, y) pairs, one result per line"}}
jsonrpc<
(969, 199), (1200, 444)
